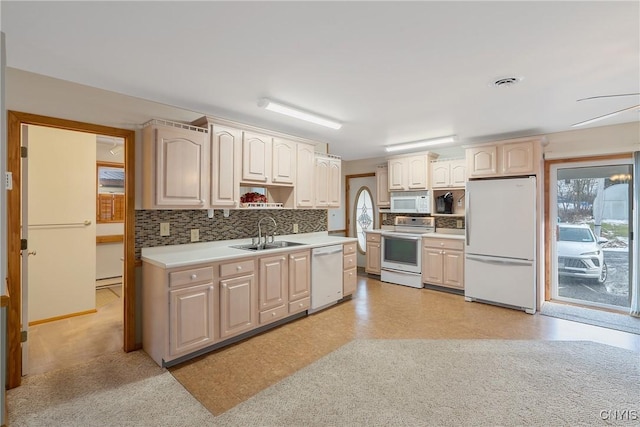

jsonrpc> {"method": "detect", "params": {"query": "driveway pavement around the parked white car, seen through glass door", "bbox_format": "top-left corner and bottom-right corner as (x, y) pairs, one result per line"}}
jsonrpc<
(558, 250), (630, 307)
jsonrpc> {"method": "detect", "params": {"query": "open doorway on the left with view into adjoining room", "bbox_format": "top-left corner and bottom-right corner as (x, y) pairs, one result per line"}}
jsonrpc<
(21, 129), (125, 375)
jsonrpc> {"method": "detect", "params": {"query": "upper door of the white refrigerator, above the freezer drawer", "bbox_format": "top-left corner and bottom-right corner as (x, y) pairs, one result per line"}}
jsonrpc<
(465, 177), (536, 260)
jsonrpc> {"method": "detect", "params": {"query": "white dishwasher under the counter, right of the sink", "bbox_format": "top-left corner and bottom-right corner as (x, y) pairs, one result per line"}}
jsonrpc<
(309, 245), (344, 313)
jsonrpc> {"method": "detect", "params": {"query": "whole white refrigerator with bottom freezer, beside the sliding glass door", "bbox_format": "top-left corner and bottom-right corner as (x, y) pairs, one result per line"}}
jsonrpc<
(464, 177), (536, 314)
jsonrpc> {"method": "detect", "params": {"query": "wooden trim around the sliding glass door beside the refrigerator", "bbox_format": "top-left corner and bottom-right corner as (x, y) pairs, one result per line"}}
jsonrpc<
(544, 153), (633, 301)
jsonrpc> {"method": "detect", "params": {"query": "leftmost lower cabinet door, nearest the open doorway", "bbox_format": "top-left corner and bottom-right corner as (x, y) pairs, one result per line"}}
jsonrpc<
(169, 283), (217, 356)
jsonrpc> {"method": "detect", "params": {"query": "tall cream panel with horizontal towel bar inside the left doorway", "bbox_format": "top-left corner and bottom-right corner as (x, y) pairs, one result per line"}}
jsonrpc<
(22, 126), (96, 332)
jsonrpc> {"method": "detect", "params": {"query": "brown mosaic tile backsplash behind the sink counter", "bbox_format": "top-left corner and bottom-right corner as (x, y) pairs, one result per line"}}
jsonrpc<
(135, 209), (328, 259)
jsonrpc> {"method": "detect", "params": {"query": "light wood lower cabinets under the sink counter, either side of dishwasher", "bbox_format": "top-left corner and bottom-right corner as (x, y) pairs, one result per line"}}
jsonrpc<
(141, 243), (344, 366)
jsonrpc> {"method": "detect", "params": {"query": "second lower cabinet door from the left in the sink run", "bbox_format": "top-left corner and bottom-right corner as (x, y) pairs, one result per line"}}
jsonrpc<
(220, 274), (257, 338)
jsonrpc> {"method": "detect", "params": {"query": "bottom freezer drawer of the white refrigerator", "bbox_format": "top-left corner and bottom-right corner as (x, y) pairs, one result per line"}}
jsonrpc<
(464, 255), (536, 314)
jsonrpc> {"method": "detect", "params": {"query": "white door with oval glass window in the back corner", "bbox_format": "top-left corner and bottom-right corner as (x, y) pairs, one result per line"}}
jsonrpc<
(347, 176), (379, 267)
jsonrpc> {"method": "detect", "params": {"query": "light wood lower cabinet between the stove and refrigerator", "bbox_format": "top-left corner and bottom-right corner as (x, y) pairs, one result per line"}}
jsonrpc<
(422, 237), (464, 289)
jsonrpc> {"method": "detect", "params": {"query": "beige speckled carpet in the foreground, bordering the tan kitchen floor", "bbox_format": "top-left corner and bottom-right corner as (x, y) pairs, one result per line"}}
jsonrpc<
(8, 340), (640, 427)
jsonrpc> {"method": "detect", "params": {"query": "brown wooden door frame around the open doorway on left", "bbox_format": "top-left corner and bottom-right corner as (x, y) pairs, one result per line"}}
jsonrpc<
(7, 111), (136, 388)
